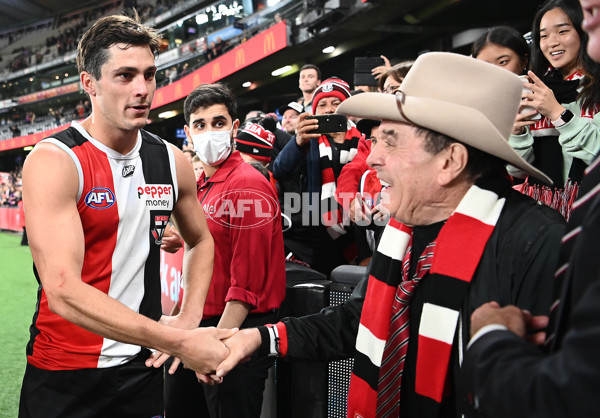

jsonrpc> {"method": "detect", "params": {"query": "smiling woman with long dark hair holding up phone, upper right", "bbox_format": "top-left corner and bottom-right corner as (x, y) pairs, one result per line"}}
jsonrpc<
(509, 0), (600, 219)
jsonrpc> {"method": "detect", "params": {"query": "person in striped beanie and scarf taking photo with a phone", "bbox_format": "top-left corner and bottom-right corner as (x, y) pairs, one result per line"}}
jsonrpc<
(273, 77), (362, 275)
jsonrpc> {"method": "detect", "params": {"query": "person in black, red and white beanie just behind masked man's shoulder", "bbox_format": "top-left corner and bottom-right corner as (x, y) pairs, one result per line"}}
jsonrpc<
(235, 123), (277, 192)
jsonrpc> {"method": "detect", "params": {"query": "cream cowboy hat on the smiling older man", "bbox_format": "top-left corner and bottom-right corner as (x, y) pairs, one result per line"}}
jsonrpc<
(337, 52), (552, 184)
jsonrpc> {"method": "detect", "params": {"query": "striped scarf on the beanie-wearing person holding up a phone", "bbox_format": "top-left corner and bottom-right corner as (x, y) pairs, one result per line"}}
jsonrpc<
(319, 127), (362, 239)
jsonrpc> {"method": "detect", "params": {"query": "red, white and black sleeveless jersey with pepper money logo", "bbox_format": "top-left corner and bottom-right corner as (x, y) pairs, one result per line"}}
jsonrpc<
(27, 122), (177, 370)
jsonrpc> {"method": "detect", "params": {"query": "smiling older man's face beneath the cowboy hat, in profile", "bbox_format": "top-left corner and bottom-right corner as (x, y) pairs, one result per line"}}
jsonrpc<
(367, 121), (444, 225)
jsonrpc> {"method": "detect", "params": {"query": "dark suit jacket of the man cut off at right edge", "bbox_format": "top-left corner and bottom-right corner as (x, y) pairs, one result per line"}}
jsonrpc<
(460, 159), (600, 418)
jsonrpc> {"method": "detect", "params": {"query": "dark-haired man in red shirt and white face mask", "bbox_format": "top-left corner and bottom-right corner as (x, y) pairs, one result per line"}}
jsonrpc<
(155, 83), (285, 418)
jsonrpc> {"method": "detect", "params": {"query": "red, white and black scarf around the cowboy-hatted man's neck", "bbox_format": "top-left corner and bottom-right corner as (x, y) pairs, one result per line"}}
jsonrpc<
(348, 181), (506, 418)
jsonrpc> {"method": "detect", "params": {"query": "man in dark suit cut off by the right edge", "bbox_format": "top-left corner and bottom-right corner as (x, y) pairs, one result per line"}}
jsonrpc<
(461, 0), (600, 418)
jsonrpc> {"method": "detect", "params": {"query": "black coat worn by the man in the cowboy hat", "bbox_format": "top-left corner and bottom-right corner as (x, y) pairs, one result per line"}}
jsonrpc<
(283, 190), (564, 417)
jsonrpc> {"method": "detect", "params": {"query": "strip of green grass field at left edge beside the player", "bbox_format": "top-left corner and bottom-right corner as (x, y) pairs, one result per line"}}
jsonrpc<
(0, 232), (37, 418)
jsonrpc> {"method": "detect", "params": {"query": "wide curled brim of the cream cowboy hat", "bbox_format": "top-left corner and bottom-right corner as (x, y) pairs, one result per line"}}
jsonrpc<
(337, 93), (552, 184)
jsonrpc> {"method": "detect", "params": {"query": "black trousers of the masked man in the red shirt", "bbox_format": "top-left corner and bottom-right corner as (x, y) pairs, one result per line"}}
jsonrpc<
(165, 313), (276, 418)
